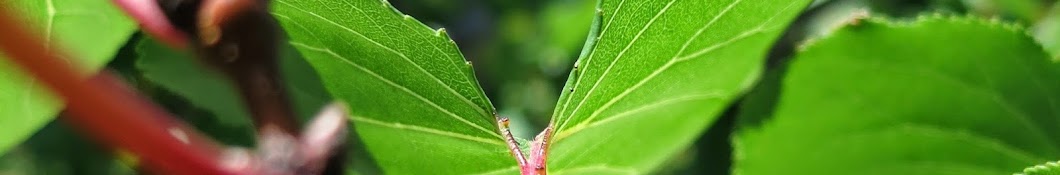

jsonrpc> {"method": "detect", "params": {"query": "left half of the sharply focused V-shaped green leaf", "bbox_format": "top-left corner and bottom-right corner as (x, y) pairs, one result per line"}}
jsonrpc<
(272, 0), (508, 174)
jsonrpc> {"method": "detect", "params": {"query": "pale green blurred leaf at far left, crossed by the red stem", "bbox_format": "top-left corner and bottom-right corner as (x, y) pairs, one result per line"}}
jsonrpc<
(0, 0), (136, 153)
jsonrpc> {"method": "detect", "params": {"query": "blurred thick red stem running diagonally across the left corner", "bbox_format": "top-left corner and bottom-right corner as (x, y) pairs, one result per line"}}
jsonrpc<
(0, 8), (247, 174)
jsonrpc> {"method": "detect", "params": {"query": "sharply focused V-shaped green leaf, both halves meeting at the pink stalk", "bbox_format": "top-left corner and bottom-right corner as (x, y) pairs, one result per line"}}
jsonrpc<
(275, 0), (809, 174)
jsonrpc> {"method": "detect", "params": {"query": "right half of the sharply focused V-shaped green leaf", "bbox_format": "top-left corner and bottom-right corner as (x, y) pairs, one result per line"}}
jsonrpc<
(548, 0), (810, 174)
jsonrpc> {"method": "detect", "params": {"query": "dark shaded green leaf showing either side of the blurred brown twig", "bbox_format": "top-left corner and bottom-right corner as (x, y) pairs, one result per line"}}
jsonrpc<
(137, 39), (331, 126)
